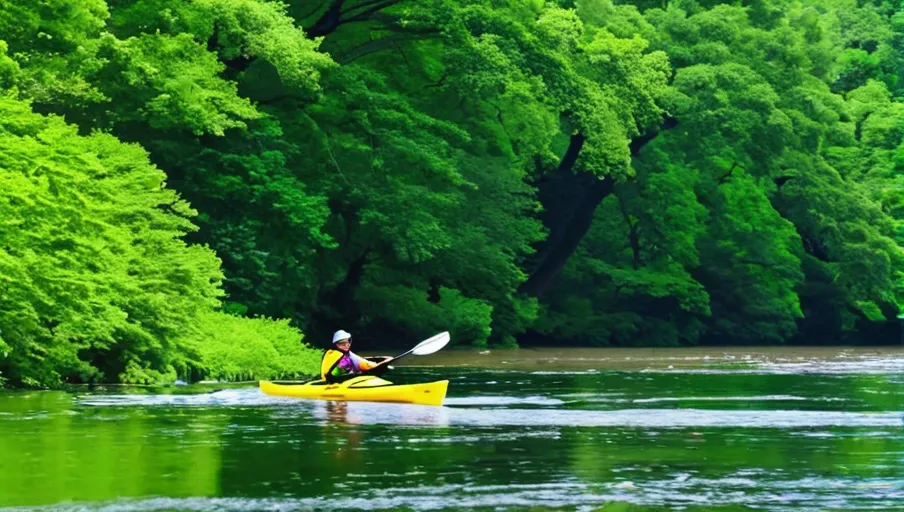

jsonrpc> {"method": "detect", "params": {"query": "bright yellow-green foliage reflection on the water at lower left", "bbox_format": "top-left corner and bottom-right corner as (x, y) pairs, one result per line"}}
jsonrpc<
(0, 393), (225, 506)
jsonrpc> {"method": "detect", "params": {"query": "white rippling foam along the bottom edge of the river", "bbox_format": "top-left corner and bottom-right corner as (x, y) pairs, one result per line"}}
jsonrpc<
(5, 473), (904, 512)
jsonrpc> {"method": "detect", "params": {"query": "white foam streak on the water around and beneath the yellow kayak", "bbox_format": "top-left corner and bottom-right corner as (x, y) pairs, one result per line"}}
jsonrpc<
(72, 388), (904, 428)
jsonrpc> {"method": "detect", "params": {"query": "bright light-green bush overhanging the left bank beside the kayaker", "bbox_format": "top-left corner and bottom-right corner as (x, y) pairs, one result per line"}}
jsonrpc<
(0, 92), (316, 385)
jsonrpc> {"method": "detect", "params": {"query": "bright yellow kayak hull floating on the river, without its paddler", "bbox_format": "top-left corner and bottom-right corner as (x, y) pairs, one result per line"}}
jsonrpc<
(260, 375), (449, 405)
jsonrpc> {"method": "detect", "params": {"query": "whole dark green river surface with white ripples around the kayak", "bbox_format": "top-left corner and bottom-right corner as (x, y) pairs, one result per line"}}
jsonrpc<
(0, 348), (904, 512)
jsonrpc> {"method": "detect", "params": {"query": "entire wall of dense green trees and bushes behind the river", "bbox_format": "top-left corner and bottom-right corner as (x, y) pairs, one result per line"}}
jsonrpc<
(0, 0), (904, 383)
